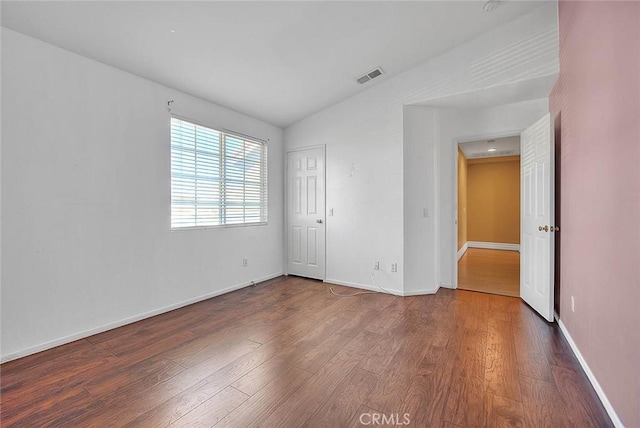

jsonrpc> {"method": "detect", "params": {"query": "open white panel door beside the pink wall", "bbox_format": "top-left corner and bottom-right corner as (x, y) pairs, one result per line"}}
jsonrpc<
(520, 113), (556, 321)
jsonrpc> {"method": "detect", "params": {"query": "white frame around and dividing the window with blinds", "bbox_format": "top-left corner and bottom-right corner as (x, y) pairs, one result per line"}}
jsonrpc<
(169, 114), (269, 232)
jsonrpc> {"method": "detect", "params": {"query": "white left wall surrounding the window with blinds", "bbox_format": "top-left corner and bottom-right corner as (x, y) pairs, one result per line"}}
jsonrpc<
(1, 29), (284, 360)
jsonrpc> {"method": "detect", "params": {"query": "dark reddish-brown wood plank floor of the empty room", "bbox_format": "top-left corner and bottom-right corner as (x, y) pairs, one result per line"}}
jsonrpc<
(1, 277), (611, 428)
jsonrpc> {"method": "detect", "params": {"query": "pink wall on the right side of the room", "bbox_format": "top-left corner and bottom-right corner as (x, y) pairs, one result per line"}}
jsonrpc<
(550, 1), (640, 427)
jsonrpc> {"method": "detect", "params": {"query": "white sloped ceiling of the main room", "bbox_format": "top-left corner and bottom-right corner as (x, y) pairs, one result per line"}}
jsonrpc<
(1, 1), (541, 127)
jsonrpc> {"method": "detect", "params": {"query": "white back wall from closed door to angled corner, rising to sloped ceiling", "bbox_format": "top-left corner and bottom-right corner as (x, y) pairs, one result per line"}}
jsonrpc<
(285, 3), (558, 294)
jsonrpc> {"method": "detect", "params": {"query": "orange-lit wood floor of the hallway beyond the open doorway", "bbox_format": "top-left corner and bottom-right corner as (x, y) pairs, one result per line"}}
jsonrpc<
(458, 248), (520, 297)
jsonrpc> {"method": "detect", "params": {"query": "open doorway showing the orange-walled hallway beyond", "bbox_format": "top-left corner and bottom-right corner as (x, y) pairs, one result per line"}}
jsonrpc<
(457, 135), (521, 297)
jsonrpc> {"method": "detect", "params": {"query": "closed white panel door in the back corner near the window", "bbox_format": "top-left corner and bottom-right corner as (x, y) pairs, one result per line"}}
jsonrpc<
(287, 148), (325, 279)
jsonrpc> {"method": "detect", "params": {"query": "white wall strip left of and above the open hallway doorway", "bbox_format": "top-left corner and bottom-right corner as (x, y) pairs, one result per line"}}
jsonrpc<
(438, 98), (549, 287)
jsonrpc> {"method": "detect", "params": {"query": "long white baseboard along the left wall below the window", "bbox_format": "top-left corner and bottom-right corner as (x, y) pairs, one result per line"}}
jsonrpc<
(0, 272), (282, 363)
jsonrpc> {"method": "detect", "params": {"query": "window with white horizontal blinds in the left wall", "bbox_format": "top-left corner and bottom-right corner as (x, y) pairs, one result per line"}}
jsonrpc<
(171, 117), (267, 229)
